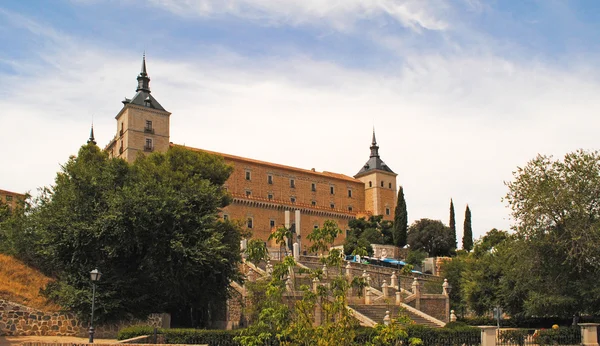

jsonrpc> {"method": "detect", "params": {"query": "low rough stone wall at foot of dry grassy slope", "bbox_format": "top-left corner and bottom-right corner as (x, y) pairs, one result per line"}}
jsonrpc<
(0, 299), (170, 338)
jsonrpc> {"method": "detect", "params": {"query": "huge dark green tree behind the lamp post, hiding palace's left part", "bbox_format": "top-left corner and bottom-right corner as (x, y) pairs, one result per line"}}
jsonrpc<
(23, 144), (241, 326)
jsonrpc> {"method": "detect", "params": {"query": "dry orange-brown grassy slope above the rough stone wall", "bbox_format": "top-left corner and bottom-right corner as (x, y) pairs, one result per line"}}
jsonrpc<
(0, 254), (60, 311)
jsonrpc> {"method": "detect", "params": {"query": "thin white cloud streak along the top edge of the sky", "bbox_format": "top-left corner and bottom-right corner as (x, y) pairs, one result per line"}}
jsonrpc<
(150, 0), (449, 31)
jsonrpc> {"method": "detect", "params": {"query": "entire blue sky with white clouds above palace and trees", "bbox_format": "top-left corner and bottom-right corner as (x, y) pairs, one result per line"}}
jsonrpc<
(0, 0), (600, 244)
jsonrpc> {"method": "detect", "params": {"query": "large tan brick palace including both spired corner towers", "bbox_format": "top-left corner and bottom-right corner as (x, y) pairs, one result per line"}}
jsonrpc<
(103, 57), (397, 248)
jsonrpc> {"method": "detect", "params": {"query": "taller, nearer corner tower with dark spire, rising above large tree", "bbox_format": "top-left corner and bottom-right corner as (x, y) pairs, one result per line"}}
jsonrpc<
(106, 53), (171, 162)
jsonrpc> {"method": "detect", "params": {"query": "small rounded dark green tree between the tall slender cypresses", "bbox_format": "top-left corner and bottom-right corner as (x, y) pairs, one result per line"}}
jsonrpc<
(408, 219), (454, 257)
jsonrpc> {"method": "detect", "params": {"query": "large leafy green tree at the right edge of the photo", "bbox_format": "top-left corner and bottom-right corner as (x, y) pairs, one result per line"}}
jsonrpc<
(503, 150), (600, 316)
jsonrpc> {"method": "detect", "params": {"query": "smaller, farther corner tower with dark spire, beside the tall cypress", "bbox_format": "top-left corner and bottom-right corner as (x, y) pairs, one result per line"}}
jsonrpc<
(354, 129), (398, 220)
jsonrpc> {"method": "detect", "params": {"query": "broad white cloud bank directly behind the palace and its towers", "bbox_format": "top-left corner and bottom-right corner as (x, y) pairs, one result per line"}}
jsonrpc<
(0, 8), (600, 242)
